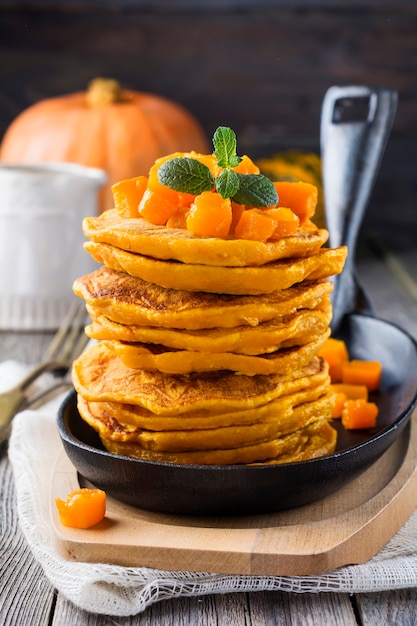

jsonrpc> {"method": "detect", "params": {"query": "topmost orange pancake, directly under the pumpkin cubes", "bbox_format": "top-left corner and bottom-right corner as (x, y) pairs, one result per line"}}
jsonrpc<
(83, 209), (328, 267)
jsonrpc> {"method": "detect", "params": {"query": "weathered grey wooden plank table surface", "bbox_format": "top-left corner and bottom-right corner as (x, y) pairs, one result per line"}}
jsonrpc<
(0, 230), (417, 626)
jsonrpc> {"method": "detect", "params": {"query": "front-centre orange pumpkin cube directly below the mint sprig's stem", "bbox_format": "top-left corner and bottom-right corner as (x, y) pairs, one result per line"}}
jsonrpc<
(186, 191), (232, 237)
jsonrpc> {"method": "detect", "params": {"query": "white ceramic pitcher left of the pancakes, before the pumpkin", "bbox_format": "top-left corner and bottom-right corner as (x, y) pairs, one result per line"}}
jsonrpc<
(0, 163), (107, 330)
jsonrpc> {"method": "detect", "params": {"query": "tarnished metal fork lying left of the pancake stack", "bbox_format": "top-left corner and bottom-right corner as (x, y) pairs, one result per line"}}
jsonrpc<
(0, 301), (89, 442)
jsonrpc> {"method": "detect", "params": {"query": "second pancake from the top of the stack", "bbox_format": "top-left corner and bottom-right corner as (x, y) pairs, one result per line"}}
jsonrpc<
(84, 241), (347, 295)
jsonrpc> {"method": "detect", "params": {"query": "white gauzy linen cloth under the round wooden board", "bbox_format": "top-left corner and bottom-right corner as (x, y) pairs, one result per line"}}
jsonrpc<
(4, 362), (417, 616)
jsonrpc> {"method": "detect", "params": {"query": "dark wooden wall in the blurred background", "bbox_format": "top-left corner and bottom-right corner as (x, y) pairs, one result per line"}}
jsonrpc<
(0, 0), (417, 247)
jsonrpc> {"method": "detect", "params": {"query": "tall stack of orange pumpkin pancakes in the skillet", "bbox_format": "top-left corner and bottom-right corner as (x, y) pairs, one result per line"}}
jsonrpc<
(73, 202), (347, 465)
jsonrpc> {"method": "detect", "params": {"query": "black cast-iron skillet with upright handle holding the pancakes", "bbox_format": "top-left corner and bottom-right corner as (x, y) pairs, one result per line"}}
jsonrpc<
(58, 87), (417, 516)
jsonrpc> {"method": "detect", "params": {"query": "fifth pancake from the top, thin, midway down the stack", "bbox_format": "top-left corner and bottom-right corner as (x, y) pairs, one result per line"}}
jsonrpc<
(112, 329), (330, 376)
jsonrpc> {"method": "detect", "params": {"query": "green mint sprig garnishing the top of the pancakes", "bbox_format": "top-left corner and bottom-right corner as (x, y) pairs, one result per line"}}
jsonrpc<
(158, 126), (278, 207)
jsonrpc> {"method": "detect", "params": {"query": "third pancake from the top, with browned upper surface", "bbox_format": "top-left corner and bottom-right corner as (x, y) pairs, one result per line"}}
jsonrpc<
(73, 267), (333, 330)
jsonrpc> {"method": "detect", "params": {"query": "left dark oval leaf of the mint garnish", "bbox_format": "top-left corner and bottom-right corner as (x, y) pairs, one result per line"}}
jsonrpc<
(158, 157), (215, 195)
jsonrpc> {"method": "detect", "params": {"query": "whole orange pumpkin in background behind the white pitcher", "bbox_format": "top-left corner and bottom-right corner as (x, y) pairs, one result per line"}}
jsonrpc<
(0, 78), (211, 212)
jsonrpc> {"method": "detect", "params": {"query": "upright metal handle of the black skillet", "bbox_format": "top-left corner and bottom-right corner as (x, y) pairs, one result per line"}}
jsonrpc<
(320, 86), (398, 334)
